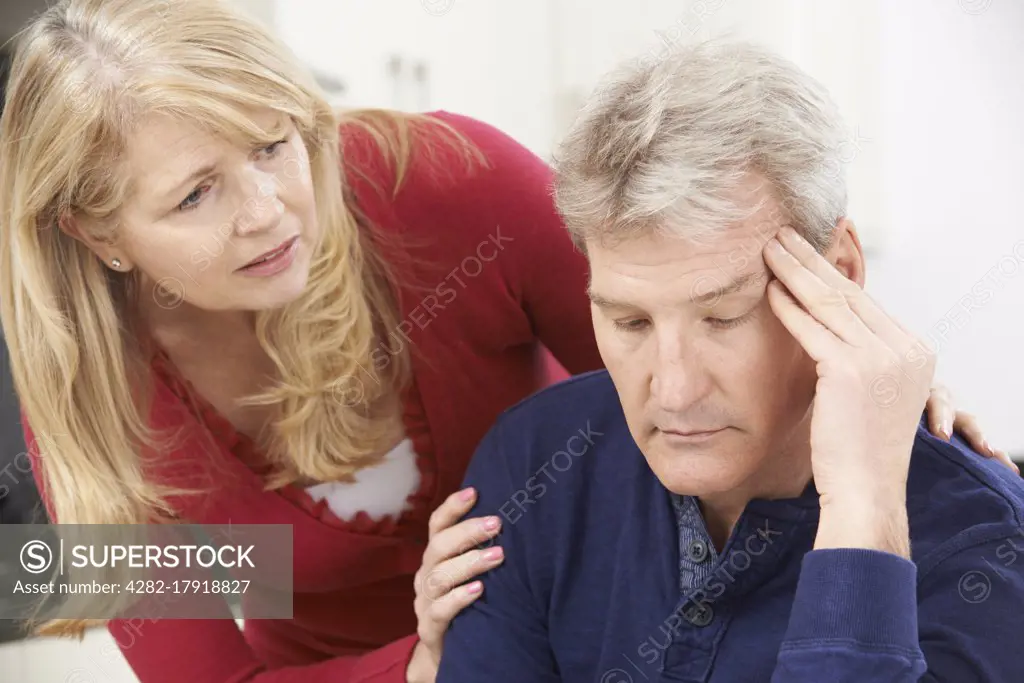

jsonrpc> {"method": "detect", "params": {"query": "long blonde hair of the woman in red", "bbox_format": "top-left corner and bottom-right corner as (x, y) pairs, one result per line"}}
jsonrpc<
(0, 0), (465, 633)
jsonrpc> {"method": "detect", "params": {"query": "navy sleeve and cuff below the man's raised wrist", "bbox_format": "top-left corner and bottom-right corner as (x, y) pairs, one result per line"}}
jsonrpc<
(771, 540), (1024, 683)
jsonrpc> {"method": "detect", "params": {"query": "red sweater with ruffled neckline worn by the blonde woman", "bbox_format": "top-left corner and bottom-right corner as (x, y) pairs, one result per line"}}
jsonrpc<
(26, 113), (601, 683)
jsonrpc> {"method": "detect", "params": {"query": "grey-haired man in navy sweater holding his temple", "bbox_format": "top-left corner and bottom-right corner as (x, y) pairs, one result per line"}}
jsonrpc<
(437, 43), (1024, 683)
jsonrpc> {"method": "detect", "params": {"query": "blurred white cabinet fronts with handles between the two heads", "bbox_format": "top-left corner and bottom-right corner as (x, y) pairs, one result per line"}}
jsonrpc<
(262, 0), (554, 155)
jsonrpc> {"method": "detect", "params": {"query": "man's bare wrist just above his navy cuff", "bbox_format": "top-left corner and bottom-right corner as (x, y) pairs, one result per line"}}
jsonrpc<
(814, 498), (910, 559)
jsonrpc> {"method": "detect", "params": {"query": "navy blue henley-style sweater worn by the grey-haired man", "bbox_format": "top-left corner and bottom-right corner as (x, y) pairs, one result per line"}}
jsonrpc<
(437, 372), (1024, 683)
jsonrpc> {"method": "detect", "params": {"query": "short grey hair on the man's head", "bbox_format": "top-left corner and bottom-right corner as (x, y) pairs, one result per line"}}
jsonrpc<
(555, 40), (847, 249)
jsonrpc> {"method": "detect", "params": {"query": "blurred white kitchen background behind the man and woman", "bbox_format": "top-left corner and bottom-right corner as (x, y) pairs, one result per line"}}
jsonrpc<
(0, 0), (1024, 683)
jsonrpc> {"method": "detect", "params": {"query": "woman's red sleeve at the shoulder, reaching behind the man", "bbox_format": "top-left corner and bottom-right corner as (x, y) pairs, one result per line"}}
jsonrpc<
(425, 113), (603, 375)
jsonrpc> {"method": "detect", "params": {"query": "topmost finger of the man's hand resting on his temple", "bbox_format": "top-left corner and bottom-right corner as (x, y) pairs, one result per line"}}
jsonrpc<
(778, 227), (915, 354)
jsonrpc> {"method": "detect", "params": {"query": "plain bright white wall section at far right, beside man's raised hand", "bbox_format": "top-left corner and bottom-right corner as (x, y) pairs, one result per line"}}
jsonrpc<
(868, 0), (1024, 456)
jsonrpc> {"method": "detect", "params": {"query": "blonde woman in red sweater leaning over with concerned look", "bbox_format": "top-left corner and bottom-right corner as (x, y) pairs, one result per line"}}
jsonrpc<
(0, 0), (1007, 683)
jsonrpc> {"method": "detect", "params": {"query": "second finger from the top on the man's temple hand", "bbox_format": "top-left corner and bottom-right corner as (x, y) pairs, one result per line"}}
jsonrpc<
(764, 232), (872, 347)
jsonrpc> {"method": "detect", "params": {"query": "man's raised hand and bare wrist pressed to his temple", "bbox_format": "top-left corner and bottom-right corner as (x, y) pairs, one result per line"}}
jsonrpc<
(765, 227), (935, 558)
